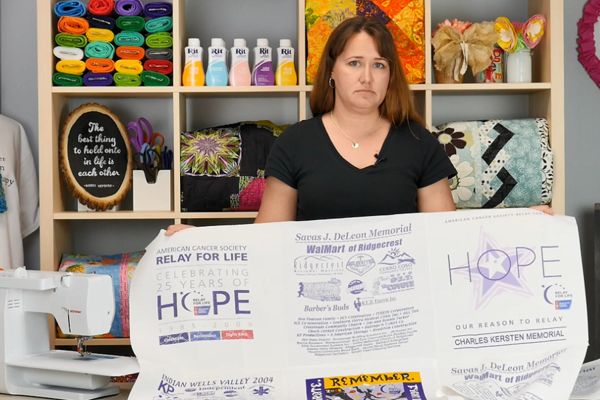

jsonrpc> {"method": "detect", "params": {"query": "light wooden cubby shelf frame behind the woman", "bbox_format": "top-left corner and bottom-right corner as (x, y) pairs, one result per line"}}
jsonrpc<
(37, 0), (565, 344)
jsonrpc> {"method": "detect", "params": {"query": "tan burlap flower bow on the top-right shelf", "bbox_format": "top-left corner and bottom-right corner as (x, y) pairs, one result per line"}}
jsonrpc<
(431, 19), (497, 83)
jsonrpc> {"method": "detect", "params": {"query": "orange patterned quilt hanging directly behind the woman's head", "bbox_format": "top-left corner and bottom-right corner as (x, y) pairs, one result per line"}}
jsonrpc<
(305, 0), (425, 85)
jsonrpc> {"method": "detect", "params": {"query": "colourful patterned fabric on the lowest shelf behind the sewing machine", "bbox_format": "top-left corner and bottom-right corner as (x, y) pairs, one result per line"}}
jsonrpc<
(57, 251), (145, 338)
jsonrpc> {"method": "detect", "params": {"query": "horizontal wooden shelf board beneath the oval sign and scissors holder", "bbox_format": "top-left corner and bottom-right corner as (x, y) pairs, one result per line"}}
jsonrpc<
(54, 211), (257, 221)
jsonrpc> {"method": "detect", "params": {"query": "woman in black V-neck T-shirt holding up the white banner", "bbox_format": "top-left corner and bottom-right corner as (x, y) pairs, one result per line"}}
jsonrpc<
(167, 17), (551, 235)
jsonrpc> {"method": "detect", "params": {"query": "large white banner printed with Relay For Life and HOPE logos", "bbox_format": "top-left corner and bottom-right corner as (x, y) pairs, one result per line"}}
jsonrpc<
(129, 209), (587, 400)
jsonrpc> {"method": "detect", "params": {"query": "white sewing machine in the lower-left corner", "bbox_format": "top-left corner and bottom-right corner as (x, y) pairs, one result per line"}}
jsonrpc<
(0, 267), (139, 400)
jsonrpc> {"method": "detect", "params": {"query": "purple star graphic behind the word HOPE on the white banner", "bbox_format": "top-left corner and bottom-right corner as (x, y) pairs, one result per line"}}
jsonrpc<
(450, 228), (535, 310)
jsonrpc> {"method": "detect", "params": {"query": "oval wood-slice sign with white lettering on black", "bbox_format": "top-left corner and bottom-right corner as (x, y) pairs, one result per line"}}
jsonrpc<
(60, 103), (133, 211)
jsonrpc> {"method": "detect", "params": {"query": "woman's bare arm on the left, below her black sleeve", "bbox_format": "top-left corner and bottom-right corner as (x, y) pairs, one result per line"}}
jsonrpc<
(254, 176), (298, 224)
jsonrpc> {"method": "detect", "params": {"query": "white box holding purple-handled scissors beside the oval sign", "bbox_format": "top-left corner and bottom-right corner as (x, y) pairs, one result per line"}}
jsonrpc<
(133, 169), (173, 211)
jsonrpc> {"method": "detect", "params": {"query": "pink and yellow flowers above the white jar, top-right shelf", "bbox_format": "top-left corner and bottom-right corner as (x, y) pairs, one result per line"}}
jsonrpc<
(494, 14), (546, 53)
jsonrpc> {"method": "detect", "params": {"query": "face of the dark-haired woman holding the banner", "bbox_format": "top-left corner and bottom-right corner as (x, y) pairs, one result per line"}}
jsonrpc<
(331, 32), (390, 112)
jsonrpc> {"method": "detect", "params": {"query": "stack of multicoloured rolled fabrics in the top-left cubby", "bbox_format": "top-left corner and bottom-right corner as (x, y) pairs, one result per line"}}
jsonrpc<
(53, 0), (173, 86)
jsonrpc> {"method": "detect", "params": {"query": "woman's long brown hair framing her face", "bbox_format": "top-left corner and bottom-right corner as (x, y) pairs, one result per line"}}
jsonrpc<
(310, 17), (425, 126)
